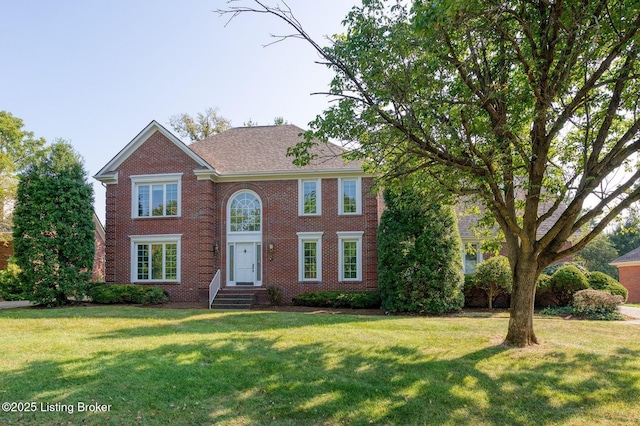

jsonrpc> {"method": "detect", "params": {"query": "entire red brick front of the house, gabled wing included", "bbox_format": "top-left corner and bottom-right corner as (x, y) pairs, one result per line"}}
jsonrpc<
(105, 132), (378, 302)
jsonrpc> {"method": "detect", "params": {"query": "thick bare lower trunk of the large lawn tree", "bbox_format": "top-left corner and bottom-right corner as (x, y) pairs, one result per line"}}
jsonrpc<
(504, 258), (539, 347)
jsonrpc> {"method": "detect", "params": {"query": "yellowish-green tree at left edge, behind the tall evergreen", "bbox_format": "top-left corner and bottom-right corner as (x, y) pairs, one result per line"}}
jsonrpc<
(0, 111), (46, 239)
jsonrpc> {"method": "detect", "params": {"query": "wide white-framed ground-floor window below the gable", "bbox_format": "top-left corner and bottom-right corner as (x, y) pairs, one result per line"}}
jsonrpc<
(131, 235), (181, 282)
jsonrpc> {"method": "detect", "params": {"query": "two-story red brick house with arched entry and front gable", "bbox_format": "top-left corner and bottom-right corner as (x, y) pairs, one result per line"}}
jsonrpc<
(94, 121), (379, 301)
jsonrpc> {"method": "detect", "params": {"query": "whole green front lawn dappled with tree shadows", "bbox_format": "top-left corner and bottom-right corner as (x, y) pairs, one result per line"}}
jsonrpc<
(0, 307), (640, 425)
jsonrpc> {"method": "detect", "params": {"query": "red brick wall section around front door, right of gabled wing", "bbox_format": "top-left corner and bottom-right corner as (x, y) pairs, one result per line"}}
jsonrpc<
(215, 178), (378, 302)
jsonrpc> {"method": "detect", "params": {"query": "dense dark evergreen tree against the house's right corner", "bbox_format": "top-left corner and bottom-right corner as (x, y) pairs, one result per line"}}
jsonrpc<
(377, 188), (464, 314)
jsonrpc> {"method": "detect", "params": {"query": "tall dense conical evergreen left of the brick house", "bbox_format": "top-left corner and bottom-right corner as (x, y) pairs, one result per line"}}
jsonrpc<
(13, 141), (95, 306)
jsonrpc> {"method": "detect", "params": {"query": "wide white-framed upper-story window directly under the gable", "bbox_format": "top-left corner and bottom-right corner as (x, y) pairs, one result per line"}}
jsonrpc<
(131, 173), (182, 217)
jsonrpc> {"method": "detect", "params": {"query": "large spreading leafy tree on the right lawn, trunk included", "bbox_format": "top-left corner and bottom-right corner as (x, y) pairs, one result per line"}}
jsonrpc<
(221, 0), (640, 346)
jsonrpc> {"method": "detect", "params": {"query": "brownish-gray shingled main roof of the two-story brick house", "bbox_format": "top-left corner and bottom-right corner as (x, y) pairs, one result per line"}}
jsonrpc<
(189, 125), (362, 174)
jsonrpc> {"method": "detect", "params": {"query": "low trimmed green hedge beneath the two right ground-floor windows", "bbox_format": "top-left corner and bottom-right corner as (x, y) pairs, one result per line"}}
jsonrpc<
(291, 291), (382, 309)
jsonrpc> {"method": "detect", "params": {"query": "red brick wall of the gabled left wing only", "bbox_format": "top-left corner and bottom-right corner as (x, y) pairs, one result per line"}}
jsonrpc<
(105, 132), (217, 301)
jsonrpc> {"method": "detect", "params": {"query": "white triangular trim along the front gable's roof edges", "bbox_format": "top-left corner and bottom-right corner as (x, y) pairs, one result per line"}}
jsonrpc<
(93, 120), (214, 184)
